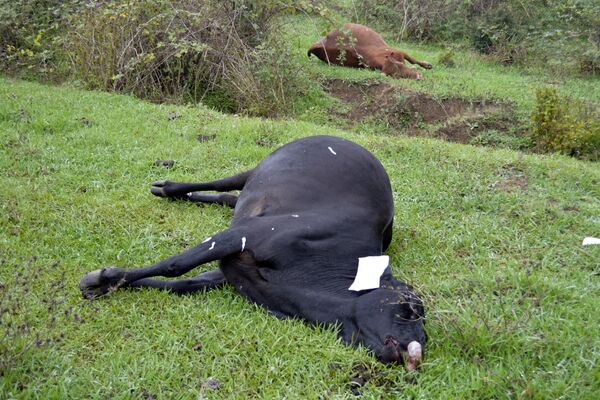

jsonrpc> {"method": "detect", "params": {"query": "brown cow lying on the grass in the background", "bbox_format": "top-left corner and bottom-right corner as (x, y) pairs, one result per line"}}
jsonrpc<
(308, 24), (431, 79)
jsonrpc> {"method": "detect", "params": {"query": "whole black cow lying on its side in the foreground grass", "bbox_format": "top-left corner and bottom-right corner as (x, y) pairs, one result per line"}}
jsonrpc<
(79, 136), (426, 369)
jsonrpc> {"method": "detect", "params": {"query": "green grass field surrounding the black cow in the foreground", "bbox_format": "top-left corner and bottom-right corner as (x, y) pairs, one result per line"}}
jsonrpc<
(0, 73), (600, 399)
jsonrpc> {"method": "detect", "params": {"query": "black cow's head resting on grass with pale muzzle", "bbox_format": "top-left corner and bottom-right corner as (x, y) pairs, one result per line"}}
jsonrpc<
(346, 281), (427, 370)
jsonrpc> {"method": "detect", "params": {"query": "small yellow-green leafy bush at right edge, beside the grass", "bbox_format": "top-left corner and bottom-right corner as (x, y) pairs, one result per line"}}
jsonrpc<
(531, 87), (600, 161)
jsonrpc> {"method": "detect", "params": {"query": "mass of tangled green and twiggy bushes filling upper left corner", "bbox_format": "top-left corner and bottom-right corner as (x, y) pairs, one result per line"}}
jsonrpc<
(0, 0), (323, 116)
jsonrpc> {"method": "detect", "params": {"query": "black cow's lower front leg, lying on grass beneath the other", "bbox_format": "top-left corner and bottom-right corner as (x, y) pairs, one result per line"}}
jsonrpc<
(128, 268), (227, 294)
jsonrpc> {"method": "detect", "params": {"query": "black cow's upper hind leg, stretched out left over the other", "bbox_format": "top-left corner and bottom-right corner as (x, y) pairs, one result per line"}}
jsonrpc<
(150, 170), (252, 199)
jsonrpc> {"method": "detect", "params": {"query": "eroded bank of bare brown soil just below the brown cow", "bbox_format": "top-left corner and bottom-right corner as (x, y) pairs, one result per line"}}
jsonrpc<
(325, 79), (517, 143)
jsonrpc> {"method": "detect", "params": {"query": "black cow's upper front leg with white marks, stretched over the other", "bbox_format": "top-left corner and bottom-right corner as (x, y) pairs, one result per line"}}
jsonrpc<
(79, 229), (246, 299)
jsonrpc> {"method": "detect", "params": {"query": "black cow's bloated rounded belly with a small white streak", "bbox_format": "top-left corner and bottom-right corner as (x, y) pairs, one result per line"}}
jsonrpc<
(233, 136), (394, 225)
